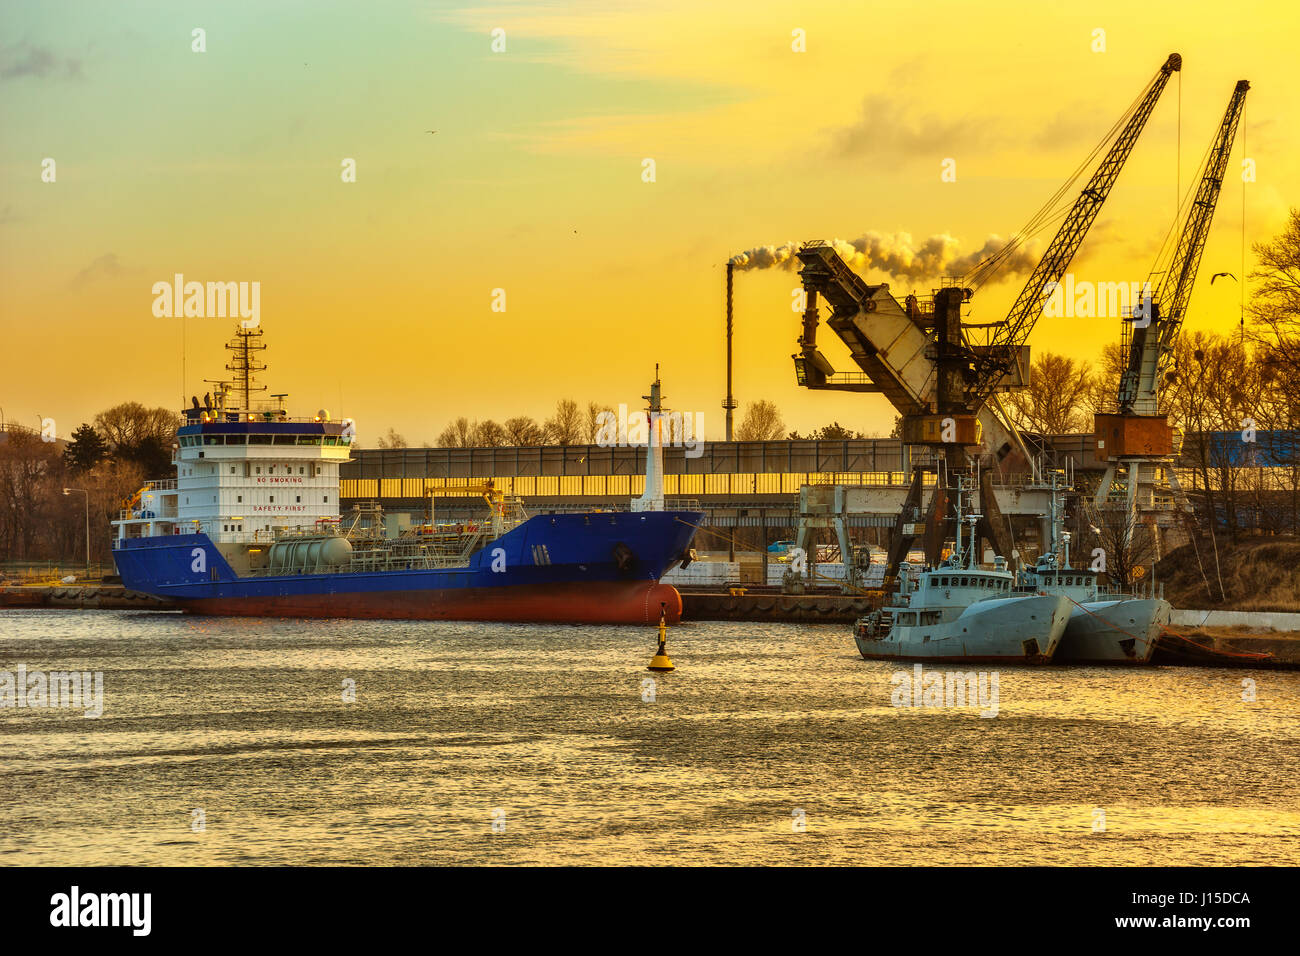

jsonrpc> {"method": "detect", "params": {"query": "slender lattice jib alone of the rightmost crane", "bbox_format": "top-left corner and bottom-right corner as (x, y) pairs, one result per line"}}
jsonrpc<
(1156, 79), (1251, 382)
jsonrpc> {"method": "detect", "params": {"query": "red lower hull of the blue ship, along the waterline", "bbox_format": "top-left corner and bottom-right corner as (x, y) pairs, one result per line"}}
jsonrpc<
(177, 581), (681, 624)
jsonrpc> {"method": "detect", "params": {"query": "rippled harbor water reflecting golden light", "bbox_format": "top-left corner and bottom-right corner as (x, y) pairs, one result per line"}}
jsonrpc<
(0, 610), (1300, 865)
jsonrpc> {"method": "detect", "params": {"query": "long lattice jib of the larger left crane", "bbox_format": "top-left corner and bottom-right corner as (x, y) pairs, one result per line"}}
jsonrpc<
(969, 53), (1183, 402)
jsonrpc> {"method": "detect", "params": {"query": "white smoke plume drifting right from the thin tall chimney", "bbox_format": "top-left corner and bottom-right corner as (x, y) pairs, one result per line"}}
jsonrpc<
(731, 233), (1041, 280)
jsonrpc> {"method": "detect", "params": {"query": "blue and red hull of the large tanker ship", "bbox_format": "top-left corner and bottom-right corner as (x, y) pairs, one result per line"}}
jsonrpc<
(113, 511), (703, 624)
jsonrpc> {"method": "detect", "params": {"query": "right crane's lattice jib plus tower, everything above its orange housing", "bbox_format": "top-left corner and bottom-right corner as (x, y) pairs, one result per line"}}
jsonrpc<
(1118, 79), (1251, 415)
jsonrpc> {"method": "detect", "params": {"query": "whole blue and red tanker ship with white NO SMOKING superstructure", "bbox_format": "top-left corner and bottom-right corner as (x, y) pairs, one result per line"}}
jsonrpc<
(113, 328), (703, 624)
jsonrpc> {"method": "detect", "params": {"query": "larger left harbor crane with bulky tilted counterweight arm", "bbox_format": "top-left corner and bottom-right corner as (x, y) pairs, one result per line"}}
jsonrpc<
(793, 53), (1182, 588)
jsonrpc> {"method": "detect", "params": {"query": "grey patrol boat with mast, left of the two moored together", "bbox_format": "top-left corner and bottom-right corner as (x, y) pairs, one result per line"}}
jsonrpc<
(854, 479), (1070, 663)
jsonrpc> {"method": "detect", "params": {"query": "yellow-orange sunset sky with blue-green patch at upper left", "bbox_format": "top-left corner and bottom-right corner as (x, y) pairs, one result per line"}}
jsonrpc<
(0, 0), (1300, 445)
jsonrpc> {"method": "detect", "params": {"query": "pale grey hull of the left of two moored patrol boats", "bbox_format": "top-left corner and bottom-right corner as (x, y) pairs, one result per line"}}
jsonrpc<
(854, 594), (1070, 663)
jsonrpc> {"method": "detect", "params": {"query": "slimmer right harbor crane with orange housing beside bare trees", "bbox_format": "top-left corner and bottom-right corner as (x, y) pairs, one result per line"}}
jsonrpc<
(1093, 79), (1251, 546)
